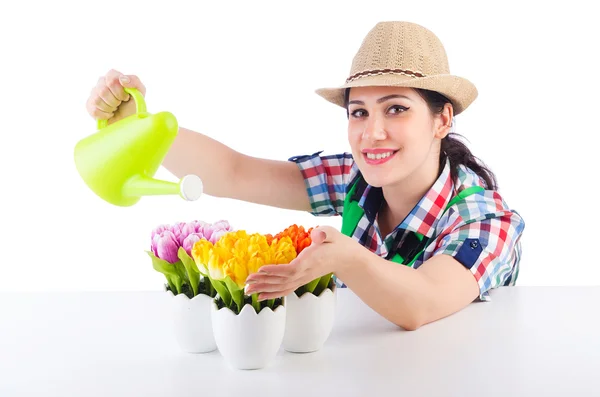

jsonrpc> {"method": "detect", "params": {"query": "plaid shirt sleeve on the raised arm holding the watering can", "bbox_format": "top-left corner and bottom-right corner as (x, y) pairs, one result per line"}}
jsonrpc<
(289, 151), (354, 216)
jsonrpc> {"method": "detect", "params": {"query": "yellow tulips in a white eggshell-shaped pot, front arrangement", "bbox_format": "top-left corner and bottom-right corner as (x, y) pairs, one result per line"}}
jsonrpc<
(191, 230), (296, 369)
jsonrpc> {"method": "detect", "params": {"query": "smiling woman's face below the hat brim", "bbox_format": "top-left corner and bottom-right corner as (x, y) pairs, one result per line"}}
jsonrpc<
(348, 87), (451, 187)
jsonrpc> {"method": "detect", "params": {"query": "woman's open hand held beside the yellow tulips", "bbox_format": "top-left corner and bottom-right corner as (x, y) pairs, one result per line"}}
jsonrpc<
(245, 226), (360, 300)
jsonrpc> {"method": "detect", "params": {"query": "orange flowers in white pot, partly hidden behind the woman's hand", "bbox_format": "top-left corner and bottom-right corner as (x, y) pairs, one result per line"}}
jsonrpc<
(273, 224), (336, 353)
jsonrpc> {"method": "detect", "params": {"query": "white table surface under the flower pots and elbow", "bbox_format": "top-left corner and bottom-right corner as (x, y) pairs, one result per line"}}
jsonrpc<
(0, 287), (600, 397)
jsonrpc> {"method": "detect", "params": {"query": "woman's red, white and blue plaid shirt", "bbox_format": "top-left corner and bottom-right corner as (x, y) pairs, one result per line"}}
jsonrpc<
(289, 152), (525, 301)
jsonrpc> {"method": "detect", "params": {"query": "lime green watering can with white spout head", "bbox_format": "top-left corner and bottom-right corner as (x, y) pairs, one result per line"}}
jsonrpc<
(75, 88), (203, 207)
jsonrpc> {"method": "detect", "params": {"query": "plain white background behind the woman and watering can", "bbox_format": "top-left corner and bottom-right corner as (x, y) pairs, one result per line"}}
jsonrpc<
(0, 0), (600, 291)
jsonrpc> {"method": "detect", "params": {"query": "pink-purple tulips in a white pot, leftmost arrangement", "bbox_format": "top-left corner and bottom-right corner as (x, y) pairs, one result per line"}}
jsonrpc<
(146, 220), (232, 353)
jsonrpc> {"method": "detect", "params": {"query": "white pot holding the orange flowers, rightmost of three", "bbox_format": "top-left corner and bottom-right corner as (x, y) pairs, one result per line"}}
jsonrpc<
(283, 285), (337, 353)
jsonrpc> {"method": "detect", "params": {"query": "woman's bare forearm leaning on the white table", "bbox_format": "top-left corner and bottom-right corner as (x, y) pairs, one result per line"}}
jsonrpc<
(335, 246), (479, 330)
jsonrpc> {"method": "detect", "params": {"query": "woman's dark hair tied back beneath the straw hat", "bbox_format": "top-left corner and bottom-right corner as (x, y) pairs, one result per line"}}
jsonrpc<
(344, 88), (498, 190)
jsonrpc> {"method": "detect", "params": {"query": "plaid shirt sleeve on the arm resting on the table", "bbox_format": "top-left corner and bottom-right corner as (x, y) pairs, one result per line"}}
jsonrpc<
(433, 192), (525, 301)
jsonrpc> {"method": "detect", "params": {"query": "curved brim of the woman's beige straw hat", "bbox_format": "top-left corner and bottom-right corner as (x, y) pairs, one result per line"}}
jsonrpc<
(315, 74), (478, 115)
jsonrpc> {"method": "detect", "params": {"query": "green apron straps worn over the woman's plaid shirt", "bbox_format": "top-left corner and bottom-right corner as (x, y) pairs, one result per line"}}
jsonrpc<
(341, 179), (485, 267)
